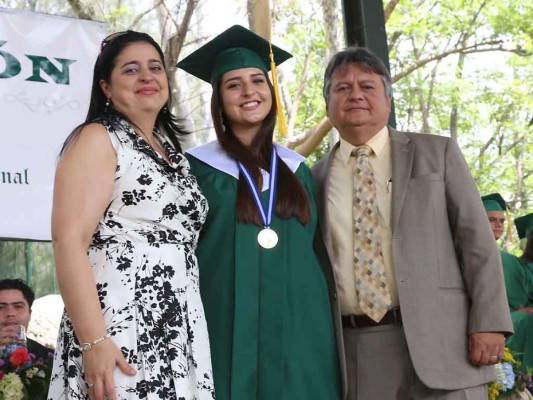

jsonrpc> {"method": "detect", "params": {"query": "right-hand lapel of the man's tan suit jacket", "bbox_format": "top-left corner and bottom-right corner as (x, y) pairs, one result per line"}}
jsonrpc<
(389, 127), (415, 234)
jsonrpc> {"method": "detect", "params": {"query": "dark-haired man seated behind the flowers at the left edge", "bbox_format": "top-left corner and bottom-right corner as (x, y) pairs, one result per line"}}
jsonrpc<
(0, 278), (54, 363)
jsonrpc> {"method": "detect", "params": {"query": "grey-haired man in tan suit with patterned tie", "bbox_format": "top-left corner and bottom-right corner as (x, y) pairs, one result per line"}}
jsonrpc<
(313, 48), (512, 400)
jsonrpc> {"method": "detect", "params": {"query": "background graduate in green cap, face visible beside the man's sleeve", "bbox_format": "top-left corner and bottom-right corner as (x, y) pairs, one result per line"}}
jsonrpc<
(481, 193), (533, 369)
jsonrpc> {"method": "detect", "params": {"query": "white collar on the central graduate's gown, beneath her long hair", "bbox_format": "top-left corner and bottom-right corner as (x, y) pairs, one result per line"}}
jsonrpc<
(187, 140), (305, 192)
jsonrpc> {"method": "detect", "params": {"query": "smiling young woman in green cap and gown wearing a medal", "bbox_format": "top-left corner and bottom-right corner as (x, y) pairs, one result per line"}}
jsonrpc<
(177, 25), (341, 400)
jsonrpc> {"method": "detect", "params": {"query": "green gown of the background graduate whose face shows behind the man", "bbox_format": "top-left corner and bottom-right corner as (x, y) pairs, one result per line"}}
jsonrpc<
(500, 250), (533, 369)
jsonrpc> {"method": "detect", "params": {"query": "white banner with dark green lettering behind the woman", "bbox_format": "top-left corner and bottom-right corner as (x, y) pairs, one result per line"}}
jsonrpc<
(0, 8), (105, 240)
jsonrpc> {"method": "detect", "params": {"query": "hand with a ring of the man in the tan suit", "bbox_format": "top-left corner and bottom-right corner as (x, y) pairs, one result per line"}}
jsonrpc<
(468, 332), (505, 365)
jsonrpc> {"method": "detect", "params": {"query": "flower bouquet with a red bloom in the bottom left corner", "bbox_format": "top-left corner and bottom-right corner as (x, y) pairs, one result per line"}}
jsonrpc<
(0, 344), (51, 400)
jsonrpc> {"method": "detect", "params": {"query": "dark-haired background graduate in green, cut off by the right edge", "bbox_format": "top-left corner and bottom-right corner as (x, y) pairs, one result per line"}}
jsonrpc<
(508, 213), (533, 374)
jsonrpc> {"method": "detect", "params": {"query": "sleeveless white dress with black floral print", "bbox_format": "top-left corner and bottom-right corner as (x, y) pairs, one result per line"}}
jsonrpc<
(48, 117), (214, 400)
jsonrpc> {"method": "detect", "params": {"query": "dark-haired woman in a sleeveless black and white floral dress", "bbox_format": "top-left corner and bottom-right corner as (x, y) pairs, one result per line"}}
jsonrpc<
(49, 31), (214, 400)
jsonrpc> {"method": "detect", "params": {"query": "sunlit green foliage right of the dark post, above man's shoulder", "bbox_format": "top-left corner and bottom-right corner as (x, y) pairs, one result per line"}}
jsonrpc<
(386, 0), (533, 216)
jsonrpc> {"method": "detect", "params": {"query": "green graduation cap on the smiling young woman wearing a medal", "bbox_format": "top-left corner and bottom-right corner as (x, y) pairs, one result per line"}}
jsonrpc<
(176, 25), (292, 85)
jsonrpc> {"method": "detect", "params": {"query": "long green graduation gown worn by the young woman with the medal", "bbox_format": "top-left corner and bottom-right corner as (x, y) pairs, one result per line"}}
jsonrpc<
(187, 142), (341, 400)
